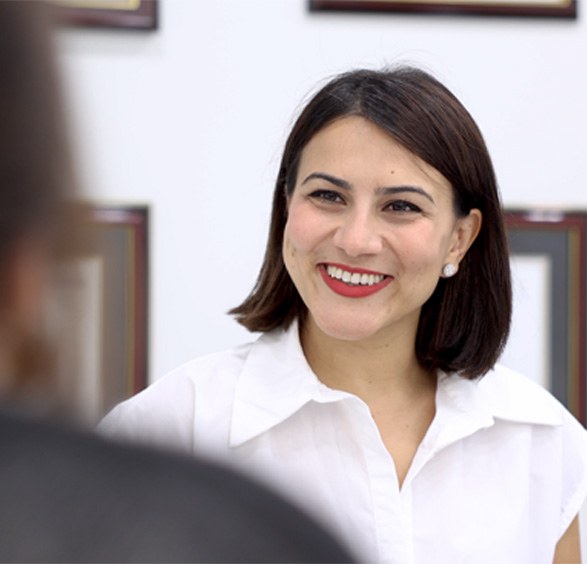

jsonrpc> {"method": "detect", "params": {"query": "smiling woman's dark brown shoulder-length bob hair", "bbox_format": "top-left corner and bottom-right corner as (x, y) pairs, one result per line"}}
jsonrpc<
(230, 66), (512, 378)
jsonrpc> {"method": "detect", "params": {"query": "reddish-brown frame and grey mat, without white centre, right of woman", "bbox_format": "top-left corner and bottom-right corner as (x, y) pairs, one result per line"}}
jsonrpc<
(506, 210), (587, 424)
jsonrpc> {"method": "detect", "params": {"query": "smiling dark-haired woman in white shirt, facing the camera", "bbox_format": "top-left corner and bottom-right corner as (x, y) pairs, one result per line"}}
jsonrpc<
(102, 67), (587, 564)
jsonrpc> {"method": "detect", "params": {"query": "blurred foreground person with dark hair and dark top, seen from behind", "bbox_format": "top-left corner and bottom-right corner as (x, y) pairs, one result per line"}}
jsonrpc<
(0, 2), (350, 562)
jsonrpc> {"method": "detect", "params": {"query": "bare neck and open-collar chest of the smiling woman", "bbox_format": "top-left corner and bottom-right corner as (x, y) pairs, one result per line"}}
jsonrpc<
(300, 318), (436, 488)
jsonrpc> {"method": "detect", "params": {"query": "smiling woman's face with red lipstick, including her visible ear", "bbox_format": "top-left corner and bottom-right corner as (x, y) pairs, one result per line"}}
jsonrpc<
(283, 116), (481, 341)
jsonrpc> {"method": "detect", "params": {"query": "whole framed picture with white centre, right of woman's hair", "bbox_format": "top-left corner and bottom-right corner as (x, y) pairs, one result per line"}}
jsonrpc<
(503, 210), (587, 425)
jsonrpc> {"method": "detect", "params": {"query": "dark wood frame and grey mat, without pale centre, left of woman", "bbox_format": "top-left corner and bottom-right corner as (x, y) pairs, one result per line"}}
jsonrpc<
(84, 205), (149, 414)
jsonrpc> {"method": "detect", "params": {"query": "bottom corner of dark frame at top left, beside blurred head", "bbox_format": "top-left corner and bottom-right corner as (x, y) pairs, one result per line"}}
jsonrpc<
(51, 0), (158, 31)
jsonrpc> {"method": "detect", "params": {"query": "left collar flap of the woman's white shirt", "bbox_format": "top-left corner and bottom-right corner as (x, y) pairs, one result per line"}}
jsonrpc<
(230, 322), (351, 447)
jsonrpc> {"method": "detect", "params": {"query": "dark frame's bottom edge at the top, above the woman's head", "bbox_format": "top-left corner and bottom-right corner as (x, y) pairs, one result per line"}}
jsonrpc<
(308, 0), (577, 19)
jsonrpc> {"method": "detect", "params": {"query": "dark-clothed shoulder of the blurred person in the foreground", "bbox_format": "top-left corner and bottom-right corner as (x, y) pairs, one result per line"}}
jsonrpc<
(0, 413), (349, 562)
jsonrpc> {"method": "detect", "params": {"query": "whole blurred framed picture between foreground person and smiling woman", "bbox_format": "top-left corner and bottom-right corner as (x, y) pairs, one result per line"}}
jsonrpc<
(51, 202), (149, 424)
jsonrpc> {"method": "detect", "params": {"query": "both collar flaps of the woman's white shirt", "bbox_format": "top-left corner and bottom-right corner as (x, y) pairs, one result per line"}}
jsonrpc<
(230, 322), (562, 447)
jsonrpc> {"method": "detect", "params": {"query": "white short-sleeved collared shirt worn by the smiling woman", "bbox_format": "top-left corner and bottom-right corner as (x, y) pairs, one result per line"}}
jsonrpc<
(100, 324), (587, 564)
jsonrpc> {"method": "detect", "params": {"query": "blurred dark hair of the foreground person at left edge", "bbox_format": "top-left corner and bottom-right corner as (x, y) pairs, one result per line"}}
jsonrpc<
(0, 1), (72, 271)
